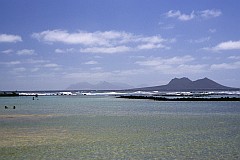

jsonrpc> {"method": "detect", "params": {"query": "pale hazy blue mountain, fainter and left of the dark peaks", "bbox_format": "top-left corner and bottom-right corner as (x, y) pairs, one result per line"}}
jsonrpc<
(67, 81), (133, 90)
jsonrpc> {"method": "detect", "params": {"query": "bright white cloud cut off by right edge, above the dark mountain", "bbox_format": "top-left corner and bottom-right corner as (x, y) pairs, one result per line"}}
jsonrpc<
(204, 40), (240, 51)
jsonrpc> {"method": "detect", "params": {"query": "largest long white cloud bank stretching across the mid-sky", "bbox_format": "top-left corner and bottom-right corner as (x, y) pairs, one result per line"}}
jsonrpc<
(32, 30), (173, 53)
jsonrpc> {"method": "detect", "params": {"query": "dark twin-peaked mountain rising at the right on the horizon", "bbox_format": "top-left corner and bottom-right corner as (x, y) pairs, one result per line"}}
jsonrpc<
(133, 77), (239, 91)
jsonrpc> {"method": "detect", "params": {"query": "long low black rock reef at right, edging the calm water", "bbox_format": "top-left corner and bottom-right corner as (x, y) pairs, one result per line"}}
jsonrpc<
(117, 95), (240, 101)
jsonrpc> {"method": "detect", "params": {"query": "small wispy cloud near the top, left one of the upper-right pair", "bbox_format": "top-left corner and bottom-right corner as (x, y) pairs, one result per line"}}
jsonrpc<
(166, 10), (195, 21)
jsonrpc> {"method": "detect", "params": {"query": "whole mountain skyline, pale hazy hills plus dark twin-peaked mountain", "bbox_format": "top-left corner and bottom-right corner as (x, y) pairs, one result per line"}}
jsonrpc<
(67, 77), (240, 91)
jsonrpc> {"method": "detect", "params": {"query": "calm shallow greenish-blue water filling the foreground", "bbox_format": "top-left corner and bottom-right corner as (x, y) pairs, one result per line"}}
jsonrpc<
(0, 96), (240, 160)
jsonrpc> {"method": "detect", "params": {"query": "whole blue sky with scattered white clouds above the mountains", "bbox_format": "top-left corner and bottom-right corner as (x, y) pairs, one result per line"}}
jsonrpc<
(0, 0), (240, 90)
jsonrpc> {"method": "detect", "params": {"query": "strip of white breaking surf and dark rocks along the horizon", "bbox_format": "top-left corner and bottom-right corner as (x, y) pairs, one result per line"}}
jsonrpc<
(0, 90), (240, 101)
